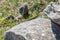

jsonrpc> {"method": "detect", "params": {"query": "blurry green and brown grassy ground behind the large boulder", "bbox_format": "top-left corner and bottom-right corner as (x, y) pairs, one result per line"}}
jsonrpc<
(0, 0), (56, 40)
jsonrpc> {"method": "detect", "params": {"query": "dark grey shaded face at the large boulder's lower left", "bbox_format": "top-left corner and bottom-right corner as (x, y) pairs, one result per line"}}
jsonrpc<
(4, 32), (26, 40)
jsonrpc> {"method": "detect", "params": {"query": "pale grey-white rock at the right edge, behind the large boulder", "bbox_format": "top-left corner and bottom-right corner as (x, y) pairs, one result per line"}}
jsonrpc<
(43, 2), (60, 25)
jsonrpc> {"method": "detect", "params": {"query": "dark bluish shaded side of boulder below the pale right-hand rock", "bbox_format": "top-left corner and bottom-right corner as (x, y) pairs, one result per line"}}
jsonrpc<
(51, 21), (60, 40)
